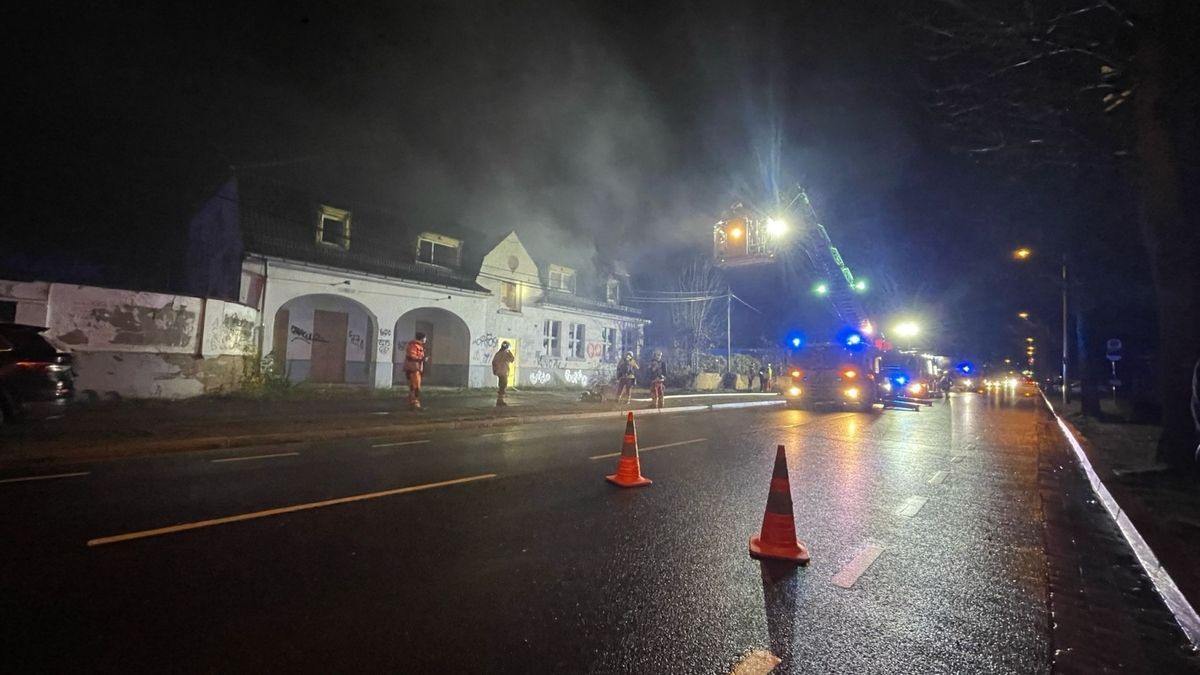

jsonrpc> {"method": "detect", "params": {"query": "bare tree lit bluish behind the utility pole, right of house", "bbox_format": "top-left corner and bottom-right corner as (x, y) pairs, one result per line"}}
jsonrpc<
(671, 257), (727, 369)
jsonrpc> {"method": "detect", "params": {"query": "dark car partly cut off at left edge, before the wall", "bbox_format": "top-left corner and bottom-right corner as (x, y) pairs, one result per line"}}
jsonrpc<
(0, 323), (74, 425)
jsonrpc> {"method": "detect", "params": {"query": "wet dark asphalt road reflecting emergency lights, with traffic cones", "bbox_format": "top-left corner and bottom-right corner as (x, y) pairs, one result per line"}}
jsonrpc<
(0, 394), (1195, 673)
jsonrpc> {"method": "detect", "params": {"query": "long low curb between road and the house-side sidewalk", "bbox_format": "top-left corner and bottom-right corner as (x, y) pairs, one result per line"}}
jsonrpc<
(0, 400), (786, 468)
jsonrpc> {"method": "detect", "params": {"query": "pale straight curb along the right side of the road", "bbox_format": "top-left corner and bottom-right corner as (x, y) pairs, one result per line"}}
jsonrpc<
(1042, 392), (1200, 649)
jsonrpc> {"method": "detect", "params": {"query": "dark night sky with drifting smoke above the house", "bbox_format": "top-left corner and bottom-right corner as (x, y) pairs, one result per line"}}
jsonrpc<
(7, 1), (1148, 357)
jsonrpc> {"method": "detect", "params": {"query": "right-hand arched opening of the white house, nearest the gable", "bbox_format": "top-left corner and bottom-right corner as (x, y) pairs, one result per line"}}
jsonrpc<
(392, 307), (470, 387)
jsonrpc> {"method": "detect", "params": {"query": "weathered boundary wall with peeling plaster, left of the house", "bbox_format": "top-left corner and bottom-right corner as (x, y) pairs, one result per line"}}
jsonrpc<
(0, 281), (258, 399)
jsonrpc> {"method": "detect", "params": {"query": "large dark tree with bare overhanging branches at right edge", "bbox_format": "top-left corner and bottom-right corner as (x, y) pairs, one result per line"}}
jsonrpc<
(906, 0), (1200, 466)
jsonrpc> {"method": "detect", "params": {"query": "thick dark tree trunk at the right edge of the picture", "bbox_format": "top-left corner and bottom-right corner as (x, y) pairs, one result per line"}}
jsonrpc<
(1134, 14), (1200, 467)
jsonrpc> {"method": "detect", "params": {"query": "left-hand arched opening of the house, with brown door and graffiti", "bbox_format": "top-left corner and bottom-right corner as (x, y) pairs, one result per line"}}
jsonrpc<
(271, 294), (377, 384)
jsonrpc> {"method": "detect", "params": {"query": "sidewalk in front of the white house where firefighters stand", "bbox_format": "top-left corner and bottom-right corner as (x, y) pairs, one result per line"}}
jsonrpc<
(0, 389), (778, 467)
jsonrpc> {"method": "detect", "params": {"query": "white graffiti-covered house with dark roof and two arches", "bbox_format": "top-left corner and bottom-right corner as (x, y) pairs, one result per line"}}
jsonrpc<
(186, 177), (648, 387)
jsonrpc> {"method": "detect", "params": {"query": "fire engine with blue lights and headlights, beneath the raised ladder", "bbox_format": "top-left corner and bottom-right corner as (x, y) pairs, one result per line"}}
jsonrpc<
(781, 344), (878, 411)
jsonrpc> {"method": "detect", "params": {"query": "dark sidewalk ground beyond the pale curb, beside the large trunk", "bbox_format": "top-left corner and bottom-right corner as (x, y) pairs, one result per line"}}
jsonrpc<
(1054, 393), (1200, 634)
